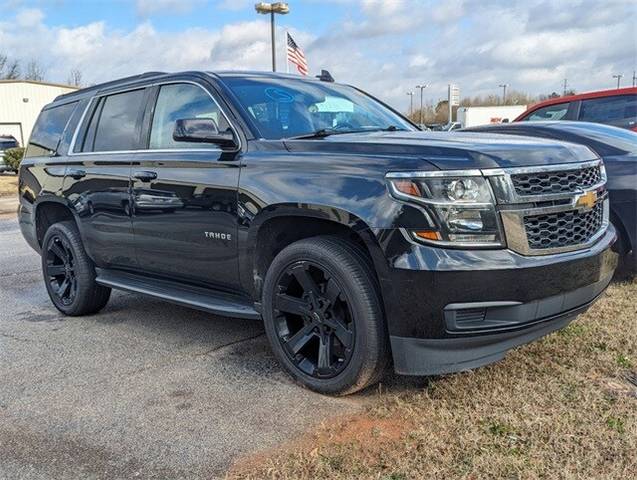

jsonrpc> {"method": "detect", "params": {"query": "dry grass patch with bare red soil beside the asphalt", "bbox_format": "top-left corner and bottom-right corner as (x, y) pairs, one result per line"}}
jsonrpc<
(228, 280), (637, 480)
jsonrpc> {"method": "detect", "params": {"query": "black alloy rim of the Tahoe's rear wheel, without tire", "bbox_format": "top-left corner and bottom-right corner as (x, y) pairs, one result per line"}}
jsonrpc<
(43, 235), (77, 306)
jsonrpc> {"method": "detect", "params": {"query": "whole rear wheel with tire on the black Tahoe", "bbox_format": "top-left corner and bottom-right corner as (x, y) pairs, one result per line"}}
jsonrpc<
(42, 221), (111, 316)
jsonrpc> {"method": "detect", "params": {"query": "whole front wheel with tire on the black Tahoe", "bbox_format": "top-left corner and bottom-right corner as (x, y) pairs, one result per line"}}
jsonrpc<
(262, 236), (389, 395)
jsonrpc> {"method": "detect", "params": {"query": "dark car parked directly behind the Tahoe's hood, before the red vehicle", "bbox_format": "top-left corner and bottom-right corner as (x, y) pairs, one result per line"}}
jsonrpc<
(465, 121), (637, 271)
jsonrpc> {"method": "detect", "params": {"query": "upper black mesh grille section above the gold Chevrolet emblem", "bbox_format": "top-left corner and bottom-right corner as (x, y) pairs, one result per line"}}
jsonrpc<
(511, 165), (602, 196)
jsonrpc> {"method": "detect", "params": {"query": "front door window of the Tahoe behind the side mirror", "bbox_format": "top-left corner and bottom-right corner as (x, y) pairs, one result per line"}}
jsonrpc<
(149, 83), (230, 149)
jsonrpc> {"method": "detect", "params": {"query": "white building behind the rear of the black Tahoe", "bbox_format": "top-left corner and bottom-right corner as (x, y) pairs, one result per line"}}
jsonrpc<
(0, 80), (77, 146)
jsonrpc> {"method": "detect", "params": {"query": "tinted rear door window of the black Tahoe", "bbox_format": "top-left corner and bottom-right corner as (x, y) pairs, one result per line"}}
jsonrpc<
(90, 90), (144, 152)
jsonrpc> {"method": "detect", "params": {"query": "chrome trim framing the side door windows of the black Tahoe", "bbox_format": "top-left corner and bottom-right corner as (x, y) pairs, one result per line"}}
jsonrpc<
(67, 80), (243, 157)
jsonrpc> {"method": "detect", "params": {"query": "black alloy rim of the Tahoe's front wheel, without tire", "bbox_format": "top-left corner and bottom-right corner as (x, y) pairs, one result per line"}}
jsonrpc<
(274, 260), (356, 379)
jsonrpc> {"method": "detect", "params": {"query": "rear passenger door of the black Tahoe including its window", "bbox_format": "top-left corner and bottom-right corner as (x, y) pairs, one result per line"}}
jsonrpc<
(64, 89), (146, 268)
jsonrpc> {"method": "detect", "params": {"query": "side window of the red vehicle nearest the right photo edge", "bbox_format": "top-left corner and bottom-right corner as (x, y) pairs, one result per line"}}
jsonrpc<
(579, 95), (637, 128)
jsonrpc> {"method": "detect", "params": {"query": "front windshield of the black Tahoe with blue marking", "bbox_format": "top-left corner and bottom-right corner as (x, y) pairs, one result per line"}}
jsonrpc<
(223, 77), (415, 140)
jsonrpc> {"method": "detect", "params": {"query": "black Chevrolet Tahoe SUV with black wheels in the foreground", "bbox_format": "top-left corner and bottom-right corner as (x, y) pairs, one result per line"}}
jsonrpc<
(19, 72), (617, 394)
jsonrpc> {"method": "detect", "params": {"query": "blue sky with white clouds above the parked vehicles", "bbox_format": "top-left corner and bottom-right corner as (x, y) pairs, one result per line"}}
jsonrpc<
(0, 0), (637, 111)
